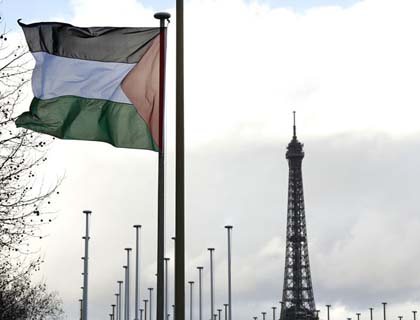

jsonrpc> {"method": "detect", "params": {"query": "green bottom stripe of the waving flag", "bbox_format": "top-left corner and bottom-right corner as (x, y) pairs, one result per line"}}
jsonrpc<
(16, 96), (159, 151)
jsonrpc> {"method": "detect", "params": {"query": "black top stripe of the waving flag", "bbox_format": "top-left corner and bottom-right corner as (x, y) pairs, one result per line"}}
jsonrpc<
(18, 21), (160, 63)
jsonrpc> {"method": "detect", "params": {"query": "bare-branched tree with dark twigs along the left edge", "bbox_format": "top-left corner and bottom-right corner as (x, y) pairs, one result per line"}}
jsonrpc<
(0, 16), (62, 320)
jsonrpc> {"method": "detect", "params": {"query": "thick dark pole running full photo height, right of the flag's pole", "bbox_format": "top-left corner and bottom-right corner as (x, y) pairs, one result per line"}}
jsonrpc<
(175, 0), (185, 320)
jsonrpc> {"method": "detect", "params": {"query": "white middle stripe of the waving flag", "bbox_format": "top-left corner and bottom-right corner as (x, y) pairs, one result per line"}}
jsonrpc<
(32, 52), (136, 103)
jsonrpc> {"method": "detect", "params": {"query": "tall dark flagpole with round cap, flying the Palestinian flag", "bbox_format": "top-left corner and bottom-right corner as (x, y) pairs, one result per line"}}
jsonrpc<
(154, 12), (171, 320)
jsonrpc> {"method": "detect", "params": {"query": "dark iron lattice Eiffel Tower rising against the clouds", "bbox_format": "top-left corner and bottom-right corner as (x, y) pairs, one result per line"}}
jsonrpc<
(281, 112), (318, 320)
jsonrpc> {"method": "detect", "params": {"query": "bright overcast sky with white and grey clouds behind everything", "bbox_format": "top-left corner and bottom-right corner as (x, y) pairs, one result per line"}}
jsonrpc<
(0, 0), (420, 320)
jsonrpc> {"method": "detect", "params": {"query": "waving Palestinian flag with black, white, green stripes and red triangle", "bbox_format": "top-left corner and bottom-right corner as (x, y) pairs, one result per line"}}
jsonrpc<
(16, 22), (161, 151)
